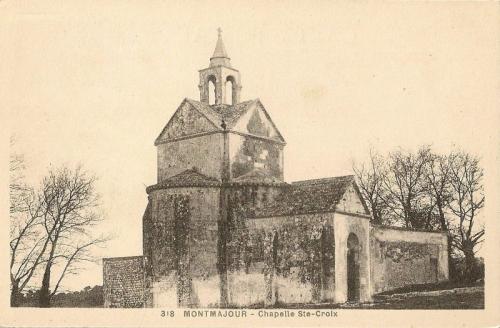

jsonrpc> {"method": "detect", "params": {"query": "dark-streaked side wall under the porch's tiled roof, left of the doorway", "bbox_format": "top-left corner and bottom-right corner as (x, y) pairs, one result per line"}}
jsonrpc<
(228, 202), (335, 306)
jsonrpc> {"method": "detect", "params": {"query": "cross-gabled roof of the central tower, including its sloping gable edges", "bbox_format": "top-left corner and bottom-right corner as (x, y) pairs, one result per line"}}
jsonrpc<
(155, 98), (285, 145)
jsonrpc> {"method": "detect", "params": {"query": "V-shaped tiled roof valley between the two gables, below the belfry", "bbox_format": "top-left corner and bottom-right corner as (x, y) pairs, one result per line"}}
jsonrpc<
(187, 99), (257, 130)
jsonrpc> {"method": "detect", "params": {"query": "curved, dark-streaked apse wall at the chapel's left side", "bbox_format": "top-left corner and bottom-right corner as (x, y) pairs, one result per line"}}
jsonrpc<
(144, 188), (220, 307)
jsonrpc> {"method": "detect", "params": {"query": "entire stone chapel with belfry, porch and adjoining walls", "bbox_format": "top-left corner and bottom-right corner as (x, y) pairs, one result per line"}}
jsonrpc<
(103, 30), (448, 308)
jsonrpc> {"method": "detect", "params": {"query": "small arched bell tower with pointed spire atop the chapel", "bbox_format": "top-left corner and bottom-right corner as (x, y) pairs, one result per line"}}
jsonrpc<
(198, 28), (241, 105)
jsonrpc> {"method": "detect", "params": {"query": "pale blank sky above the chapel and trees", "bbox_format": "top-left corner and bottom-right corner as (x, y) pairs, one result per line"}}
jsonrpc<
(0, 0), (500, 289)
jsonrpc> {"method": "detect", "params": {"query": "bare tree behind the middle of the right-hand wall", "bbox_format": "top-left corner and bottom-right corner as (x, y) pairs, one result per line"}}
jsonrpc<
(382, 146), (433, 228)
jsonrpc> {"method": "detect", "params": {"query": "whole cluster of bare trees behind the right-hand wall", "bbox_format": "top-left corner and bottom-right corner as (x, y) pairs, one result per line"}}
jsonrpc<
(353, 146), (484, 279)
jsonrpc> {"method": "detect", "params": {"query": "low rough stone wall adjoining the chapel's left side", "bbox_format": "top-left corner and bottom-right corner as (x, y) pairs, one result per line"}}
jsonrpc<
(103, 256), (145, 308)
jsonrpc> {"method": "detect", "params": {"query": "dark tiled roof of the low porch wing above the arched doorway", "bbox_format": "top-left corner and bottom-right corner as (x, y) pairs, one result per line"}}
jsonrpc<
(255, 175), (354, 217)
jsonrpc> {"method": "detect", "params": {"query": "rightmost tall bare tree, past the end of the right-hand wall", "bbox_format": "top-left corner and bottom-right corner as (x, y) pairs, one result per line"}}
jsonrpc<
(449, 152), (484, 280)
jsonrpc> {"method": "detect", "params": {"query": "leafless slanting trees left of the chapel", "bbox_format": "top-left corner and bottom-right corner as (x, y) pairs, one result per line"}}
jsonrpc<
(9, 138), (107, 307)
